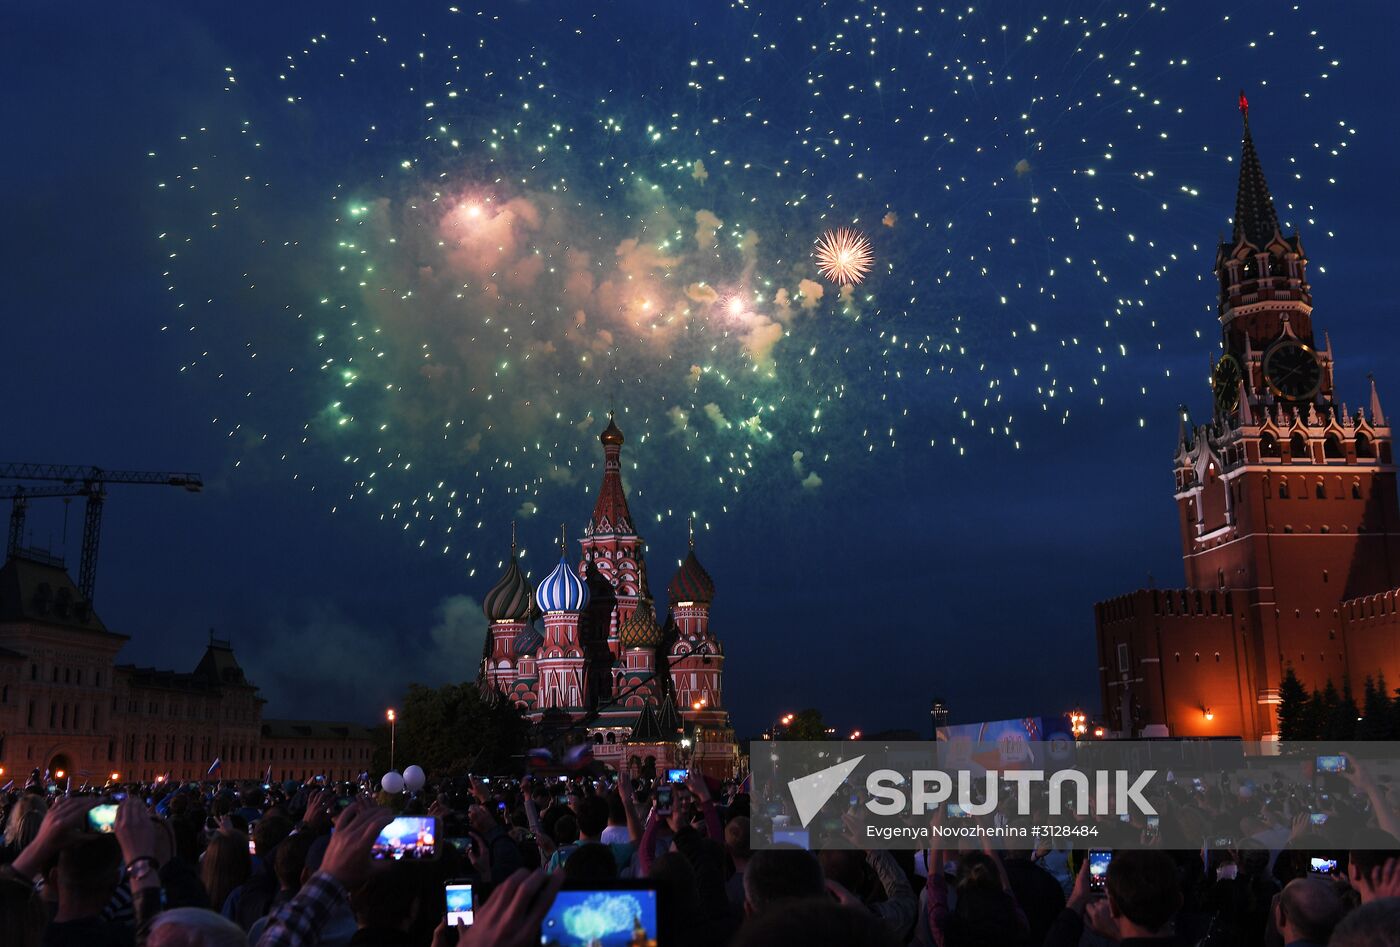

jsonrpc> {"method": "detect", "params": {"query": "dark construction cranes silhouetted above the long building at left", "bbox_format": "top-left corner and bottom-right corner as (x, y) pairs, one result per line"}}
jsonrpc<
(0, 464), (204, 604)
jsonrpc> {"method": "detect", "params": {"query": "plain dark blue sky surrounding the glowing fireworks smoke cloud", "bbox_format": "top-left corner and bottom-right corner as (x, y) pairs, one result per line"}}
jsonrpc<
(0, 3), (1400, 733)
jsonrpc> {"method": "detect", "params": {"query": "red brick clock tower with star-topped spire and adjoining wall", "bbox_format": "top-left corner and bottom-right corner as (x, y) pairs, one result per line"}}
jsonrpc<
(1095, 95), (1400, 740)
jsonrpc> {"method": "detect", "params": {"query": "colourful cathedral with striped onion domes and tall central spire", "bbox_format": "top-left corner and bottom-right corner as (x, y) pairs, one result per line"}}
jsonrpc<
(477, 416), (738, 775)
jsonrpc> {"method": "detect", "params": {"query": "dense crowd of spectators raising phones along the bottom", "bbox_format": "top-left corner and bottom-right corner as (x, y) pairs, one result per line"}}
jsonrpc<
(0, 769), (1400, 947)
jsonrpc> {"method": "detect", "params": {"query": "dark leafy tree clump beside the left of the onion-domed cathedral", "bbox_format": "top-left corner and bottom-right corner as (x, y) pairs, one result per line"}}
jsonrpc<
(374, 682), (526, 777)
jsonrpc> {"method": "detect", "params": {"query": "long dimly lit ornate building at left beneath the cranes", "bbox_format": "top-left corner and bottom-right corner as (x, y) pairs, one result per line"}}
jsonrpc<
(0, 549), (371, 786)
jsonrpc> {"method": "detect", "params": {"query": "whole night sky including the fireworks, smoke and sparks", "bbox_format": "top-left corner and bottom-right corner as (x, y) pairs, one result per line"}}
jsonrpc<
(0, 0), (1400, 735)
